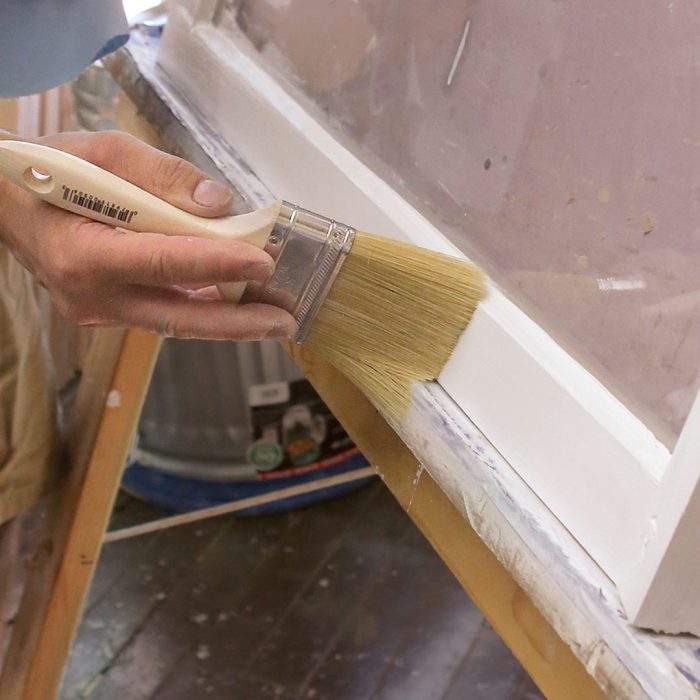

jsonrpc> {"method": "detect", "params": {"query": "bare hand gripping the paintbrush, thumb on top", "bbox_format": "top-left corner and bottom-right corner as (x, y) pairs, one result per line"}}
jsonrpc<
(0, 132), (296, 340)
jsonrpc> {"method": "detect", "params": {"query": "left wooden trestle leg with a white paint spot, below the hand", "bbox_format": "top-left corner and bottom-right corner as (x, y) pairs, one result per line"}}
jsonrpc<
(0, 329), (161, 700)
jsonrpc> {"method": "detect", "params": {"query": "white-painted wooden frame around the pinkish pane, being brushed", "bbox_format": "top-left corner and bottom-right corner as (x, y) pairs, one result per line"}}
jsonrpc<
(159, 0), (700, 634)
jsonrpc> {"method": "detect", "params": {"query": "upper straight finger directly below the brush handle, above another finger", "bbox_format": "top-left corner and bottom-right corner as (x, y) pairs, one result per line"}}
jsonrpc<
(75, 221), (273, 286)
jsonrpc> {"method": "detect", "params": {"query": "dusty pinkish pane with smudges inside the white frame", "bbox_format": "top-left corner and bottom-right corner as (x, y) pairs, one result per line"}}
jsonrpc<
(219, 0), (700, 445)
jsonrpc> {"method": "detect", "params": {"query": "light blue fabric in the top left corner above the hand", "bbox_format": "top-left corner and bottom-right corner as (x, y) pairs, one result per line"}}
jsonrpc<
(0, 0), (129, 97)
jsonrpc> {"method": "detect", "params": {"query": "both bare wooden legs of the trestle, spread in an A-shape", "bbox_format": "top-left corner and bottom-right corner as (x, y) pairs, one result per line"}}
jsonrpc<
(0, 330), (605, 700)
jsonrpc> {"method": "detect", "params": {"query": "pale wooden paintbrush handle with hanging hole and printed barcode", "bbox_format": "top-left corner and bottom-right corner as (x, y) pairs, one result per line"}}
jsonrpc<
(0, 141), (281, 302)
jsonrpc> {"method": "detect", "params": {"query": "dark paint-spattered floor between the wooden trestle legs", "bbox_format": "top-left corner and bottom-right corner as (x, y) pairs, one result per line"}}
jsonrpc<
(60, 482), (543, 700)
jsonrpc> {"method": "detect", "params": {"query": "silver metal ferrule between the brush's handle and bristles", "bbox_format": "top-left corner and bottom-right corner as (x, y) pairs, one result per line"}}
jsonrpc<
(249, 202), (356, 343)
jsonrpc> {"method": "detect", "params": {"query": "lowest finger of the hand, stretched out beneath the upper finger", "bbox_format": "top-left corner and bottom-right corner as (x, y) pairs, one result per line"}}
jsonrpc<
(105, 287), (296, 340)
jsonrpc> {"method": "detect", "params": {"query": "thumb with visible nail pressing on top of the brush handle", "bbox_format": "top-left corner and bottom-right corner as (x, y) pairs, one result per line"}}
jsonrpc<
(45, 131), (233, 216)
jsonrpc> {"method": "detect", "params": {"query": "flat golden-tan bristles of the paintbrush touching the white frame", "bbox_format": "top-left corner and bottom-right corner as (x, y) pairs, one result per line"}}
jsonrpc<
(305, 233), (485, 420)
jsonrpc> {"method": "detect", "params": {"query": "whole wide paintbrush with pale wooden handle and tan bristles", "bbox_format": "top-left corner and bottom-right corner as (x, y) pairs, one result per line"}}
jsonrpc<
(0, 141), (485, 420)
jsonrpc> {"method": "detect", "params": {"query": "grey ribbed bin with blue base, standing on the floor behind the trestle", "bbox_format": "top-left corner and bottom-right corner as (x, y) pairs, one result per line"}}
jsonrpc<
(122, 339), (367, 515)
